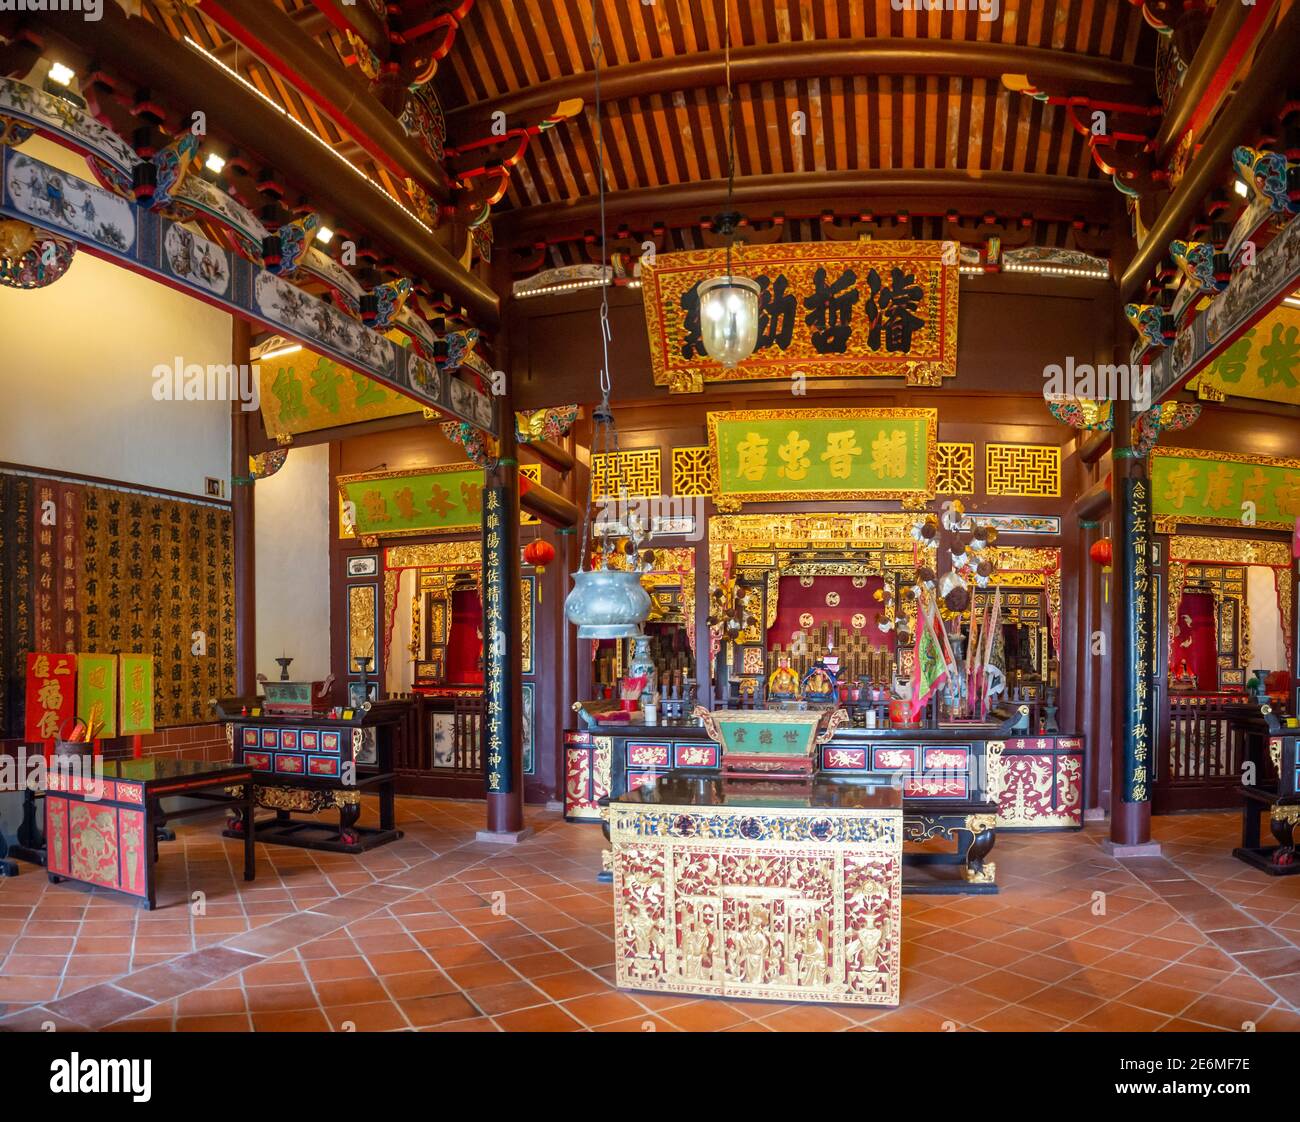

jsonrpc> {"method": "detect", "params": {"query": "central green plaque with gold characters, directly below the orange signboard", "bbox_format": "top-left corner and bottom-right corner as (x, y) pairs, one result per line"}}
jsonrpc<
(709, 410), (939, 508)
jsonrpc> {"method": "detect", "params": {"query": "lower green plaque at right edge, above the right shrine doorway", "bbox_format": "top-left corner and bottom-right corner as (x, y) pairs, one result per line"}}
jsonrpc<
(1151, 449), (1300, 530)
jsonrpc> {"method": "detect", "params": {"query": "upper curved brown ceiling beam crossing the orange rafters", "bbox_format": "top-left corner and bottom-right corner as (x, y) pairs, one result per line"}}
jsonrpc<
(447, 39), (1154, 143)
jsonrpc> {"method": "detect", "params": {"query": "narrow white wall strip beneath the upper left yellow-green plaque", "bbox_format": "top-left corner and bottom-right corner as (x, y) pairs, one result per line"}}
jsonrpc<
(254, 445), (330, 681)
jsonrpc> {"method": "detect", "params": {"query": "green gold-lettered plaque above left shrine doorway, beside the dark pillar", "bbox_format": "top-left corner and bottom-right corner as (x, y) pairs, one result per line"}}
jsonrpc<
(338, 463), (484, 537)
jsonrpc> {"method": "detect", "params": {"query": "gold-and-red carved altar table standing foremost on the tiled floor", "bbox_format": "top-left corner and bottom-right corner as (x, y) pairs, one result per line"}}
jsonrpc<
(608, 772), (902, 1005)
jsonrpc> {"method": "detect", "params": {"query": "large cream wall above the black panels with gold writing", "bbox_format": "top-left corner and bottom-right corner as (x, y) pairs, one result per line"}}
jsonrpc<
(0, 138), (230, 495)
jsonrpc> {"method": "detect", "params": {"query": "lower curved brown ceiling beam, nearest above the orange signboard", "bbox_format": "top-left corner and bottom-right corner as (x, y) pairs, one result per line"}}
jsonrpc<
(493, 168), (1115, 246)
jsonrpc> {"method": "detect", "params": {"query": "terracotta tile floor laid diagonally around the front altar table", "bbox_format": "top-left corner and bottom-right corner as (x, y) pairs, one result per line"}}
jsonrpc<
(0, 800), (1300, 1031)
